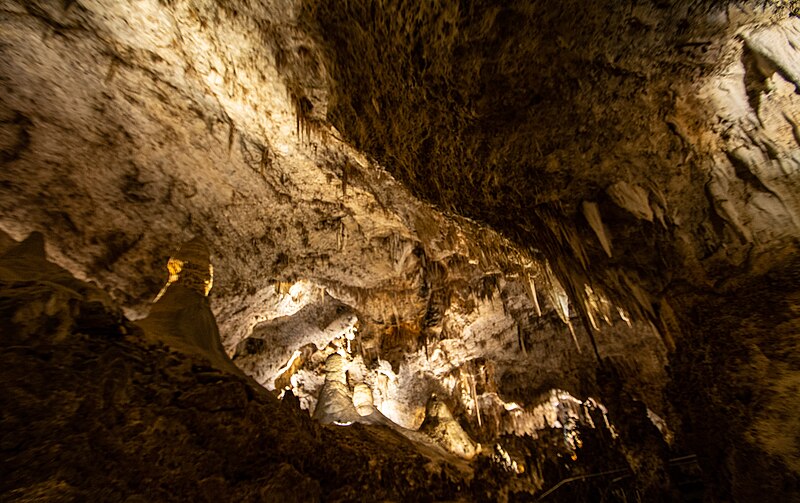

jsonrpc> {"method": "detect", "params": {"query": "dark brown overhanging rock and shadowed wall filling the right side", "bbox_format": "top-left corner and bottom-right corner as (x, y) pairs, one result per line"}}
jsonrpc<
(303, 1), (800, 500)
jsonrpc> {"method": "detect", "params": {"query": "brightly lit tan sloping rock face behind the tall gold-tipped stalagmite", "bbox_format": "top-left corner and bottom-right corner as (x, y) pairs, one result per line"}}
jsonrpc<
(2, 1), (510, 348)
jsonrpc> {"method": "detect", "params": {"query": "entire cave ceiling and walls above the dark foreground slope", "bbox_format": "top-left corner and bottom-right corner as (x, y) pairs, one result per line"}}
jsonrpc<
(0, 0), (800, 495)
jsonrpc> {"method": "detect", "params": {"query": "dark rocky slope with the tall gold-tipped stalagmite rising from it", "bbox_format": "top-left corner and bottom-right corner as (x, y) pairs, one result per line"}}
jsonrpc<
(0, 233), (488, 502)
